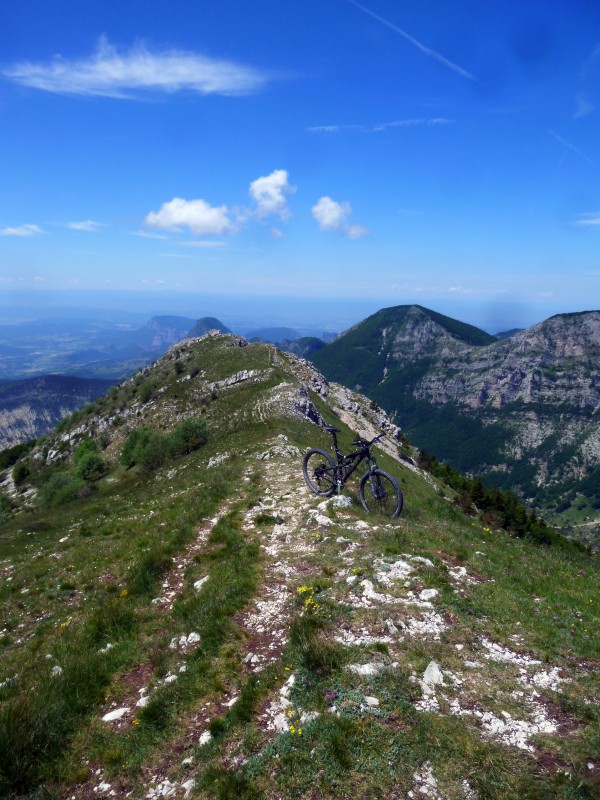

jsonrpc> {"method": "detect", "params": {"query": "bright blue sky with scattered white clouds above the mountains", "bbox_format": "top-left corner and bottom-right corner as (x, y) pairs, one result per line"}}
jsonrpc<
(0, 0), (600, 324)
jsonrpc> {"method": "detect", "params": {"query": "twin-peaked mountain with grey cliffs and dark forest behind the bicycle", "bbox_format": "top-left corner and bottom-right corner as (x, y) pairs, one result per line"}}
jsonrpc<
(311, 306), (600, 544)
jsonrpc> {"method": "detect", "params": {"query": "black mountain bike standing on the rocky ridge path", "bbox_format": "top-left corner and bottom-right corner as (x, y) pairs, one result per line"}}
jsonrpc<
(302, 425), (404, 517)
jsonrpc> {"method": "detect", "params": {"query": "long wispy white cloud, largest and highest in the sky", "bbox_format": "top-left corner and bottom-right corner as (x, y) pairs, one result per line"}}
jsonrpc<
(3, 36), (268, 99)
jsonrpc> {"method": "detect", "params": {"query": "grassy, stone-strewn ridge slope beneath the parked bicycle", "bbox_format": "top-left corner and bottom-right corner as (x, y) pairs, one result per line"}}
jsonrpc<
(0, 339), (600, 798)
